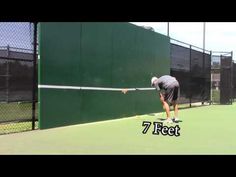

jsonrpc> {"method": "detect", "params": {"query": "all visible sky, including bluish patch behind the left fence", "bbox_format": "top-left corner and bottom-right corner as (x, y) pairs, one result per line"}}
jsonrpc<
(0, 22), (236, 60)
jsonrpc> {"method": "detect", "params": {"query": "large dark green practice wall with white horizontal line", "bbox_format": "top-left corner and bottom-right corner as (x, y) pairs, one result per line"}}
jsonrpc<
(39, 22), (170, 129)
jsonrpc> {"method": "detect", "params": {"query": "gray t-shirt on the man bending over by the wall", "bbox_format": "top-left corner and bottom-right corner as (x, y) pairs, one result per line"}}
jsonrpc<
(155, 75), (179, 90)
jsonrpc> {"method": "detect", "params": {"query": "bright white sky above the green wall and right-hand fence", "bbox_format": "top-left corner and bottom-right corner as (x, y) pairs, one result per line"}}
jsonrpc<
(131, 22), (236, 61)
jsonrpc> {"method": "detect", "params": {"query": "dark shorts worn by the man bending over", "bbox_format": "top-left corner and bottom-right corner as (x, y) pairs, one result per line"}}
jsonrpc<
(164, 84), (180, 104)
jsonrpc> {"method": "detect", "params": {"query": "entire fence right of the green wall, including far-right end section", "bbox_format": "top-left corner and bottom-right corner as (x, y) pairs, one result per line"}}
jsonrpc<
(171, 39), (233, 107)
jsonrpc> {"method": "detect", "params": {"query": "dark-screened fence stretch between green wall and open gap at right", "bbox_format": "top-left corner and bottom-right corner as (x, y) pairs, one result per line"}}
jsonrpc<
(171, 39), (211, 107)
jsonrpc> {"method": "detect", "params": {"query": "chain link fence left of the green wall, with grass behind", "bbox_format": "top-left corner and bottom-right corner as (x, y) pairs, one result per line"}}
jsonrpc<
(0, 22), (37, 134)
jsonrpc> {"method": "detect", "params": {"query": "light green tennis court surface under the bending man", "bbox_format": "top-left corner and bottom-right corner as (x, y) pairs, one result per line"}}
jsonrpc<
(0, 104), (236, 154)
